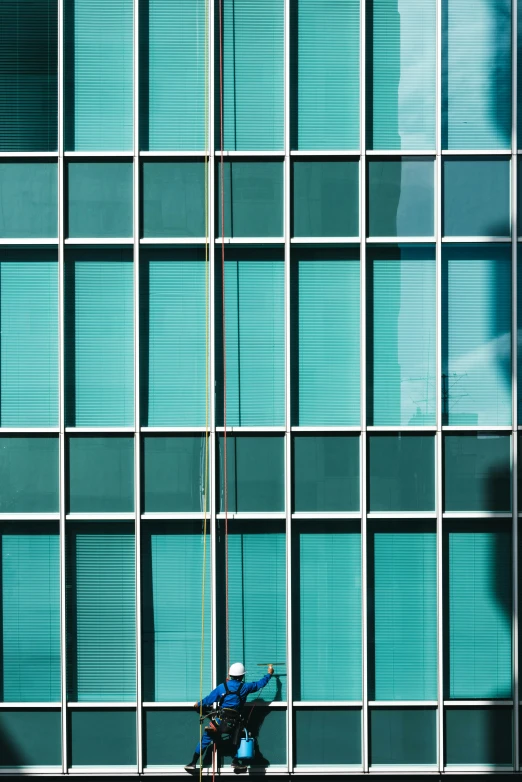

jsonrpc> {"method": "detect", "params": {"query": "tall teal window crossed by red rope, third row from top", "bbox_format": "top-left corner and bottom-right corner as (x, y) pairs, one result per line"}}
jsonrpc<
(213, 248), (285, 426)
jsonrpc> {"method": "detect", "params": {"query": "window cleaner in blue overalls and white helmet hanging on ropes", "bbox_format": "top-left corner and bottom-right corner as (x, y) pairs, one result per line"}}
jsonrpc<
(185, 663), (274, 772)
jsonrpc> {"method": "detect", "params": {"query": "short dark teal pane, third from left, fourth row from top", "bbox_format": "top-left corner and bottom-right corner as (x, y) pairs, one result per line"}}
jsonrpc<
(142, 435), (209, 516)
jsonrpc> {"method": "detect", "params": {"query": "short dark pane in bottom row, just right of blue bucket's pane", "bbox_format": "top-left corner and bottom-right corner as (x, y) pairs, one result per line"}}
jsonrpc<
(294, 707), (362, 766)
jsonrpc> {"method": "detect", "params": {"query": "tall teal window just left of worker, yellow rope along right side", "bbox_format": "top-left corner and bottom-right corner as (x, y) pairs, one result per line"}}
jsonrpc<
(141, 521), (212, 704)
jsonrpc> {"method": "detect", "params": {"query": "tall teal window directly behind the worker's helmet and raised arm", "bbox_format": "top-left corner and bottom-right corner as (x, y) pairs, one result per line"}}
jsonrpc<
(225, 521), (287, 708)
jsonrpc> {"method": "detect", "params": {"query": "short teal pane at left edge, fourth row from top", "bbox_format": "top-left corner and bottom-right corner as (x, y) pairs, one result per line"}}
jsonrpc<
(0, 435), (59, 513)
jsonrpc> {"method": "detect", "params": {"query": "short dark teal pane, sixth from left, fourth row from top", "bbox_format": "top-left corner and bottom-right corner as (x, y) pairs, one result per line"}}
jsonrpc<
(368, 433), (435, 513)
